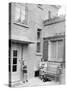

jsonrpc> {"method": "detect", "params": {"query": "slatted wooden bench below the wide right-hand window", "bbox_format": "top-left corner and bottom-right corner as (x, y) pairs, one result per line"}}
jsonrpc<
(45, 62), (61, 81)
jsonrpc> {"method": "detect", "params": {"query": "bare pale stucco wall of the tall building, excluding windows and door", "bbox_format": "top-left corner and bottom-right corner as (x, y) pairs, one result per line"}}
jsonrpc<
(11, 4), (57, 78)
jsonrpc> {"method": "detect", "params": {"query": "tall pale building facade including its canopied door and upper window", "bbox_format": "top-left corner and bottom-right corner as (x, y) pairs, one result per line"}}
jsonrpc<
(9, 3), (61, 86)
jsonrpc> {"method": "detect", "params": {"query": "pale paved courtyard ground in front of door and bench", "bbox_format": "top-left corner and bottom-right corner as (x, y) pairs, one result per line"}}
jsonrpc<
(14, 78), (59, 87)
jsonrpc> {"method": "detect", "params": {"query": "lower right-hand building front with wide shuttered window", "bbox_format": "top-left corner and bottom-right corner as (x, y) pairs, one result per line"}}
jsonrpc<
(42, 16), (65, 63)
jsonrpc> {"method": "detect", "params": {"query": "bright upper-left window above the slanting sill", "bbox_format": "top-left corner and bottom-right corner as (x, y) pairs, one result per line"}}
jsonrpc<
(15, 4), (25, 23)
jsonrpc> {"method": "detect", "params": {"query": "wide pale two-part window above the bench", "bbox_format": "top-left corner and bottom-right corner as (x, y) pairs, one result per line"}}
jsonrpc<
(51, 40), (63, 59)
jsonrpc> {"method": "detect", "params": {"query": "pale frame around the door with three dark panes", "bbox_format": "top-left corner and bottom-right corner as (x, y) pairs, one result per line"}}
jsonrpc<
(9, 43), (23, 86)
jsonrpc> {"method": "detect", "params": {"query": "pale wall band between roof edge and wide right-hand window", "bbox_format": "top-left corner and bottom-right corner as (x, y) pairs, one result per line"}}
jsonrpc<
(42, 22), (65, 37)
